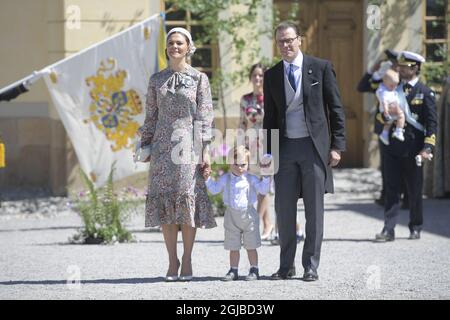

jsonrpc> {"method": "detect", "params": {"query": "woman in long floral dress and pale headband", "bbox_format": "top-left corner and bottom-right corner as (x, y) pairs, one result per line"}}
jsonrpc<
(140, 28), (216, 281)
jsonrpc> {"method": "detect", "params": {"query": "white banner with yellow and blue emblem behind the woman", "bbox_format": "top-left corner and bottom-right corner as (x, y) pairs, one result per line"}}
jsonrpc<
(45, 15), (165, 187)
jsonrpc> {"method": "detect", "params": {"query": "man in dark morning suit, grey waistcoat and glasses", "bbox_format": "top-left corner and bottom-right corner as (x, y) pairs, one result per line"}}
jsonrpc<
(263, 22), (345, 281)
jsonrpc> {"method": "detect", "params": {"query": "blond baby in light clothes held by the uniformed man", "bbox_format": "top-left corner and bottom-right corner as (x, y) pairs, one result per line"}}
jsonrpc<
(376, 69), (405, 145)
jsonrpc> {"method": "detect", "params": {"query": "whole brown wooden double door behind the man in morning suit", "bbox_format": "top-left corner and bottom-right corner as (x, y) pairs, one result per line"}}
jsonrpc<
(274, 0), (365, 167)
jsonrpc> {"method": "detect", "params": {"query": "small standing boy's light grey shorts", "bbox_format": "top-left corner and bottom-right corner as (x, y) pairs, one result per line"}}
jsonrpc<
(224, 207), (261, 251)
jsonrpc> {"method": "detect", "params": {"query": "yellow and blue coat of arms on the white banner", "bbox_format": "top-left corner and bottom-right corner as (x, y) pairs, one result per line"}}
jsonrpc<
(85, 58), (142, 152)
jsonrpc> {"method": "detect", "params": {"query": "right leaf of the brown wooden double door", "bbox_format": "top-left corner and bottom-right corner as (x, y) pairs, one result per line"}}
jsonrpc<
(317, 0), (365, 167)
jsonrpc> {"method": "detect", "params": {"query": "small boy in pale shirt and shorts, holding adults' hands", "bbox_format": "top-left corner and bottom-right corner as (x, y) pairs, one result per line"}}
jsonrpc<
(206, 146), (270, 281)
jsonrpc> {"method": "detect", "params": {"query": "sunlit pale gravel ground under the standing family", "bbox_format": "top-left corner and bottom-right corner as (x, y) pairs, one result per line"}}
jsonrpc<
(0, 169), (450, 300)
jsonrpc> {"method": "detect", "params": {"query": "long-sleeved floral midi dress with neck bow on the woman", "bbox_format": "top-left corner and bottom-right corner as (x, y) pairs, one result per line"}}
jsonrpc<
(140, 66), (216, 228)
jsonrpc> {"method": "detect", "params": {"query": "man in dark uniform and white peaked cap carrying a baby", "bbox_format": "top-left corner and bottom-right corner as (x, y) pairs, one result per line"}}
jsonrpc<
(376, 51), (437, 241)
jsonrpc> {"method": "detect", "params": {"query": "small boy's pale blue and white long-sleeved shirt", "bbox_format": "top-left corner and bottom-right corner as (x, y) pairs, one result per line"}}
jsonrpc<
(206, 172), (270, 210)
